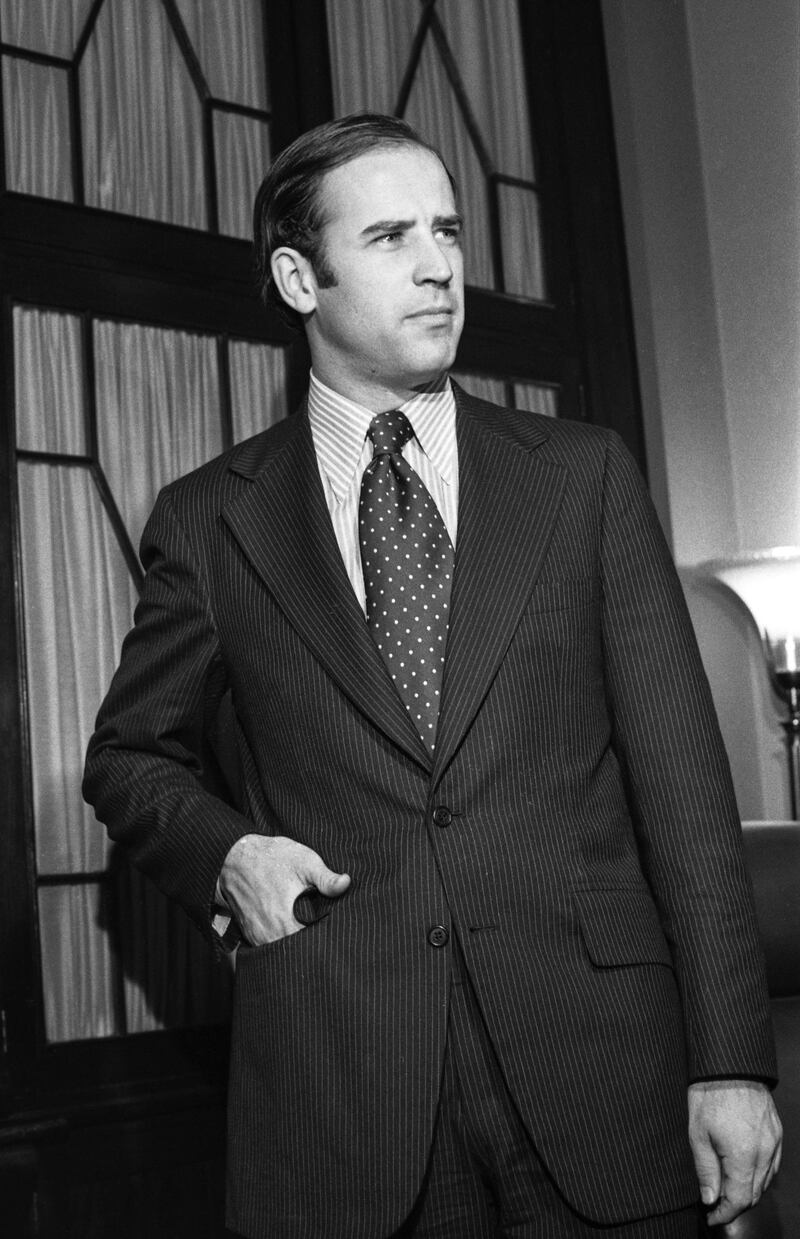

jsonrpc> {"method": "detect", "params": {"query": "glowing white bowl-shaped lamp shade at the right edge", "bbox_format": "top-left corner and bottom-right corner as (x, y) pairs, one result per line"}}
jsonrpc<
(703, 546), (800, 686)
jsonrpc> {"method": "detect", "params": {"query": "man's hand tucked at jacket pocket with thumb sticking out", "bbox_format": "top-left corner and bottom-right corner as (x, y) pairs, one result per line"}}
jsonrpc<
(219, 835), (350, 947)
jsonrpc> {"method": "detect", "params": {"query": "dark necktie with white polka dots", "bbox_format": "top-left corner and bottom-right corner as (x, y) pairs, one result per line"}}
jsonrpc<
(358, 410), (453, 752)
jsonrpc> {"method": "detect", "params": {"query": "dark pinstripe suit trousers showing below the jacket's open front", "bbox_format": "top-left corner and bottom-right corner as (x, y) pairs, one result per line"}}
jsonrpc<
(395, 940), (706, 1239)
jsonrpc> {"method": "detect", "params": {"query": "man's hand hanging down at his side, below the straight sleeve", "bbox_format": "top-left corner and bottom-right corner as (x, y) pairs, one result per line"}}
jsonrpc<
(689, 1080), (783, 1225)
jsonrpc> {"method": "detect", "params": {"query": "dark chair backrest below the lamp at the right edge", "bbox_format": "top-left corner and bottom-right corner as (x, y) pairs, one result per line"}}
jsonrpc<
(742, 821), (800, 997)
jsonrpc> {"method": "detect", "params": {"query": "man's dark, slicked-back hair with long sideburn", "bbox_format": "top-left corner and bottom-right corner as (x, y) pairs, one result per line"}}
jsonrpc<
(253, 112), (456, 328)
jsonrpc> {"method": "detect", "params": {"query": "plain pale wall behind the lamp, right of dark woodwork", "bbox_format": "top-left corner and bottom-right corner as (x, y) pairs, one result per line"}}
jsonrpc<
(603, 0), (800, 819)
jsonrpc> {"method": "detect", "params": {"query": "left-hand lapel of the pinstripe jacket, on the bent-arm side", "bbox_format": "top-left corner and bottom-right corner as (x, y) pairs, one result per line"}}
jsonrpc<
(223, 409), (431, 769)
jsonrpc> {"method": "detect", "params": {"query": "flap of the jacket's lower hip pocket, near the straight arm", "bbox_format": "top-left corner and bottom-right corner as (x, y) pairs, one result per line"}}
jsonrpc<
(573, 888), (672, 968)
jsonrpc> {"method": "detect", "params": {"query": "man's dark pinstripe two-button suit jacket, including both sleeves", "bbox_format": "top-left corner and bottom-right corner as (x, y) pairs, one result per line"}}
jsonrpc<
(85, 392), (775, 1239)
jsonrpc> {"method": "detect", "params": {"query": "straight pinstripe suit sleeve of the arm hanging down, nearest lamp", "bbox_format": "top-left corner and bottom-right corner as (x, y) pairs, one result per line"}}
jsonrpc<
(602, 435), (776, 1079)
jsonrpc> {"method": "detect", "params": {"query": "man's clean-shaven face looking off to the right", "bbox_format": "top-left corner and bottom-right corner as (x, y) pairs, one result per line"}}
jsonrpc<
(306, 146), (463, 410)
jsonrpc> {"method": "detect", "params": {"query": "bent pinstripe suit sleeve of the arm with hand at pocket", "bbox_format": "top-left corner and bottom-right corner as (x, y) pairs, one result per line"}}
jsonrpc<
(83, 492), (253, 935)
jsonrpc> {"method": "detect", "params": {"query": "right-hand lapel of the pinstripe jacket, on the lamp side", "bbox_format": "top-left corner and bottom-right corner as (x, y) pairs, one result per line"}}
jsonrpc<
(433, 389), (565, 779)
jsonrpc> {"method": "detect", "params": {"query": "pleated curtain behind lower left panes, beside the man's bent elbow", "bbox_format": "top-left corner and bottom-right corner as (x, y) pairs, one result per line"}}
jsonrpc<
(14, 306), (286, 1041)
